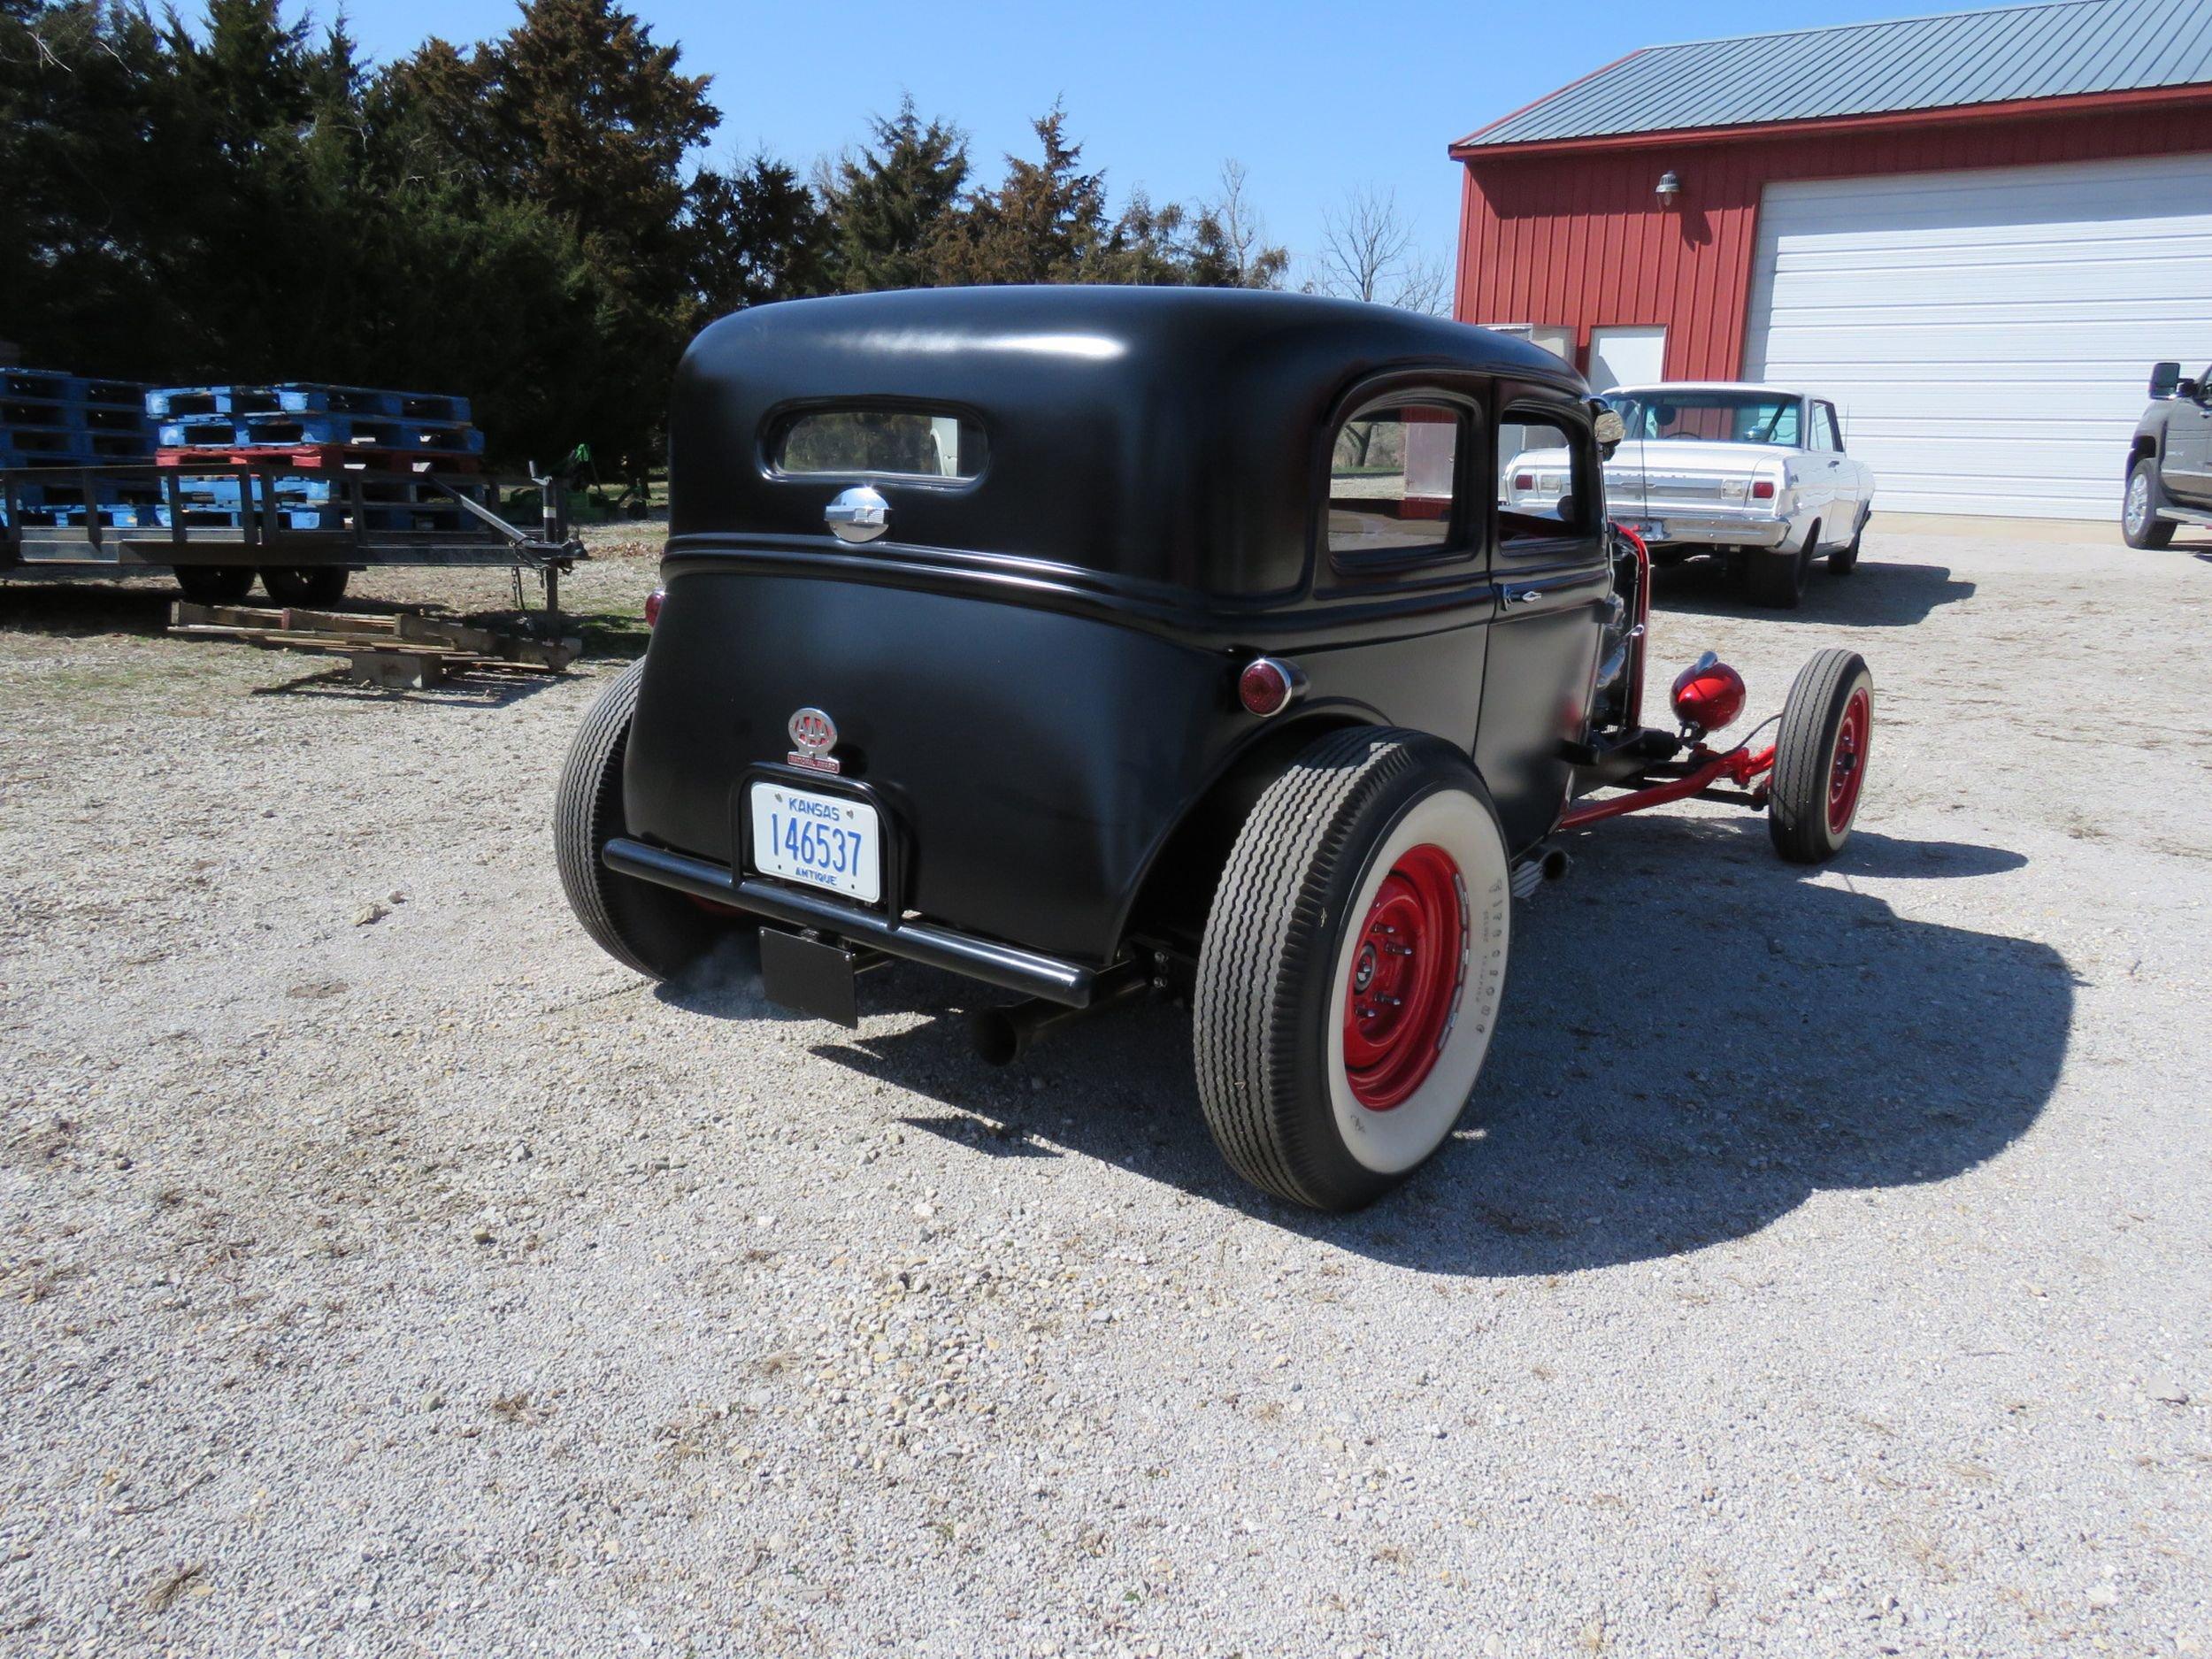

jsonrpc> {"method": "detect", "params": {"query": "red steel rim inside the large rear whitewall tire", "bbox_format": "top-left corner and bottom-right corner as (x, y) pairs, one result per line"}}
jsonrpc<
(1345, 843), (1467, 1113)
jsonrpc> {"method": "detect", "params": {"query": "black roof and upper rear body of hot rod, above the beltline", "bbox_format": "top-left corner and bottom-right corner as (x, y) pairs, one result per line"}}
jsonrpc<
(668, 286), (1588, 595)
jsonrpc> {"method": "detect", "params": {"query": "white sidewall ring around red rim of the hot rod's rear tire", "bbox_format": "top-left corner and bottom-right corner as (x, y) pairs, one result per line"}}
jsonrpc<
(1323, 787), (1513, 1175)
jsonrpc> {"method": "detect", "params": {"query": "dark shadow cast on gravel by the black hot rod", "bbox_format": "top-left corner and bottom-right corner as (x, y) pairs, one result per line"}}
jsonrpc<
(814, 818), (2075, 1277)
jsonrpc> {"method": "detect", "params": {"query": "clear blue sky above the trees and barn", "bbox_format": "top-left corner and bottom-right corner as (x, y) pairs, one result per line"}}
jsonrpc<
(336, 0), (1947, 264)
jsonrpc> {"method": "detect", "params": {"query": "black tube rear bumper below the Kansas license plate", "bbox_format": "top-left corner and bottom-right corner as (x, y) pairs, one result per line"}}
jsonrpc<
(602, 836), (1100, 1009)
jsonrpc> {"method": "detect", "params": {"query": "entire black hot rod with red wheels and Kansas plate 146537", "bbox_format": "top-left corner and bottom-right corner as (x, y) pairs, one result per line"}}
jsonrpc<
(556, 288), (1874, 1208)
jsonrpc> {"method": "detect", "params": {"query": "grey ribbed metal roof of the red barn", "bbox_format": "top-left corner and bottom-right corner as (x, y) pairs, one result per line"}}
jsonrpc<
(1454, 0), (2212, 149)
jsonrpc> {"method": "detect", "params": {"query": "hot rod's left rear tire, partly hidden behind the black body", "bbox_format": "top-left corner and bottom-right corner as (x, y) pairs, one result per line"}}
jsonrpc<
(553, 659), (750, 980)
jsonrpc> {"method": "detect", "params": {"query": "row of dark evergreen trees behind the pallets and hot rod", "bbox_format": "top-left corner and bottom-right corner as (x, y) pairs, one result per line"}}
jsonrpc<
(0, 0), (1281, 467)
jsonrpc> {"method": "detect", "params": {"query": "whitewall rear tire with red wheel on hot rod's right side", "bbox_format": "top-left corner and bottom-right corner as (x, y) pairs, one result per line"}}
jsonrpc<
(1194, 728), (1511, 1210)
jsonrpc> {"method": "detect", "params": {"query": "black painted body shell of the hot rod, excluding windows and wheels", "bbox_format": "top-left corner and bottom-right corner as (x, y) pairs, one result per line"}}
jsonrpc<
(626, 288), (1610, 964)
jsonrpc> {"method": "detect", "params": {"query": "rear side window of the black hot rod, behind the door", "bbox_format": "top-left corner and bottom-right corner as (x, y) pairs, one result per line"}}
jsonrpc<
(1330, 401), (1467, 566)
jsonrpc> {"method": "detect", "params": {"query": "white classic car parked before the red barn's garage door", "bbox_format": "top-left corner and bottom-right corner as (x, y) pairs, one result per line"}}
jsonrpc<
(1498, 380), (1874, 606)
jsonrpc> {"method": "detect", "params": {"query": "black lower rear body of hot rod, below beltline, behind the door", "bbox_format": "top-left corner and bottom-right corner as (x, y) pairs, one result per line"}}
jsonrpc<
(624, 556), (1486, 963)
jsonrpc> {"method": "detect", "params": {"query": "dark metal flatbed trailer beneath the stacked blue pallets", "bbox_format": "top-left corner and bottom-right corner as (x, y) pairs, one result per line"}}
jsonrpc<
(0, 460), (588, 615)
